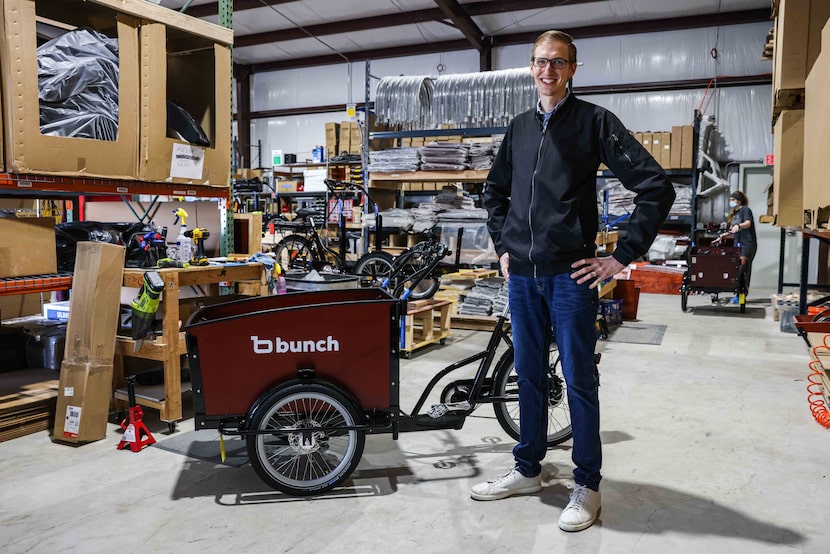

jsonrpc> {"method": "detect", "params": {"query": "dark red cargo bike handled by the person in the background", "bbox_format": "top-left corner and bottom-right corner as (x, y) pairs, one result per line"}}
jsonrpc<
(680, 237), (748, 313)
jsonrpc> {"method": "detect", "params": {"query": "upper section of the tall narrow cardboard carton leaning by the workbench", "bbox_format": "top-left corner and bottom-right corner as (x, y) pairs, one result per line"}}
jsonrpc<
(64, 242), (125, 365)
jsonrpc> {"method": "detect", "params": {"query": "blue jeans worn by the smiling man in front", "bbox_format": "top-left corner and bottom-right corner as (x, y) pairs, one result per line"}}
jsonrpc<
(509, 273), (602, 489)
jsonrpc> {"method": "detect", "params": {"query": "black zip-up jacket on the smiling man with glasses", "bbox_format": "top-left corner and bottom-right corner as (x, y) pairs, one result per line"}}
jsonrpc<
(484, 94), (674, 277)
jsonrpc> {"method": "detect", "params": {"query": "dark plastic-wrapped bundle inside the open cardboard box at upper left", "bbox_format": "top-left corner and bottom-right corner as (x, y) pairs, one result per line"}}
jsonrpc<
(37, 29), (118, 140)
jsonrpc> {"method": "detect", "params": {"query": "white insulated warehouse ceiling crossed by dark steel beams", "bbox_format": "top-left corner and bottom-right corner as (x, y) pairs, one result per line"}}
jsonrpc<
(153, 0), (770, 71)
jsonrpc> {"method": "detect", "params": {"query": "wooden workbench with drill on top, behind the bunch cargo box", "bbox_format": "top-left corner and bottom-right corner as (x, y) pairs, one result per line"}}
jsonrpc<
(113, 263), (268, 422)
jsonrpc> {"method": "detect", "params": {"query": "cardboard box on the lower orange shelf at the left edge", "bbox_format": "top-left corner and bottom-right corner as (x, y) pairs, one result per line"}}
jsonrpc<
(0, 217), (58, 278)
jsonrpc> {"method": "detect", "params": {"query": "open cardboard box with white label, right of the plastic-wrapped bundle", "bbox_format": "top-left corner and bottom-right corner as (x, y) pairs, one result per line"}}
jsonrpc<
(139, 22), (231, 187)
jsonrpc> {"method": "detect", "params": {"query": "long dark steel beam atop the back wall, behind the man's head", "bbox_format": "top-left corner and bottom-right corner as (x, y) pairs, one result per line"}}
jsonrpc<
(247, 8), (770, 73)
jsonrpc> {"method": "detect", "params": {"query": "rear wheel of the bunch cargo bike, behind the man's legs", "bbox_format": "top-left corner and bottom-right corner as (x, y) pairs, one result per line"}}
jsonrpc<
(493, 346), (573, 446)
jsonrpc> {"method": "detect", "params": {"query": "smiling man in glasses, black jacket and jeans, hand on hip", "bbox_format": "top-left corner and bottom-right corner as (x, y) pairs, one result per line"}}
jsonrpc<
(470, 31), (674, 531)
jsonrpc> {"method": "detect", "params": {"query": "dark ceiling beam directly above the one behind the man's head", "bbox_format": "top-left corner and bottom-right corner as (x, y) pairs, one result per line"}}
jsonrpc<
(232, 0), (605, 47)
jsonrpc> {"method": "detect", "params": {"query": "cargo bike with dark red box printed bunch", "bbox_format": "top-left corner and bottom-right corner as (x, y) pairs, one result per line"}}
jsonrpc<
(186, 288), (580, 496)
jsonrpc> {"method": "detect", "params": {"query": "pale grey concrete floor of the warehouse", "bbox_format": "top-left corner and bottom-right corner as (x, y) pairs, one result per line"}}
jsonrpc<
(0, 291), (830, 554)
